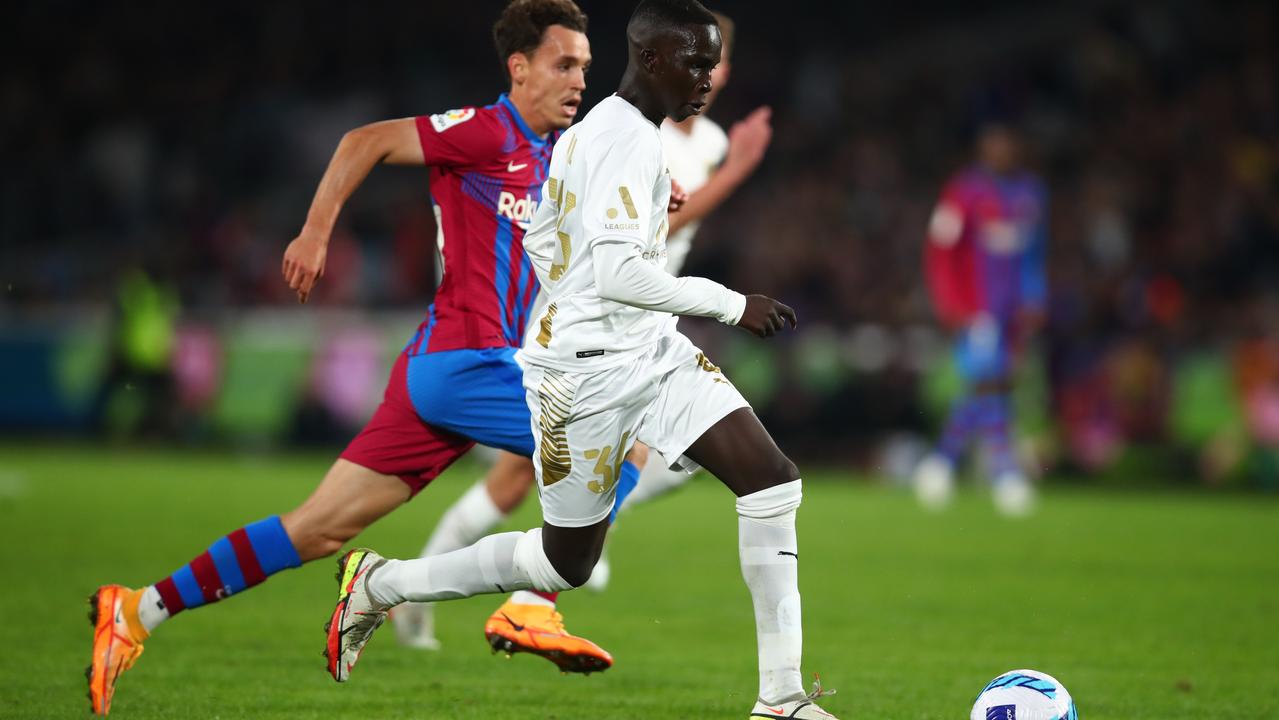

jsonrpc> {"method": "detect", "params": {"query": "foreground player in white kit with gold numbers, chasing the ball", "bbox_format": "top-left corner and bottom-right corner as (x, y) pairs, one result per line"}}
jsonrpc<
(329, 0), (833, 719)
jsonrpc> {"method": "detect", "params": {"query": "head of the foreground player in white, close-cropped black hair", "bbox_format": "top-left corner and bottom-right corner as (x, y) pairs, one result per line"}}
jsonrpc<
(627, 0), (721, 121)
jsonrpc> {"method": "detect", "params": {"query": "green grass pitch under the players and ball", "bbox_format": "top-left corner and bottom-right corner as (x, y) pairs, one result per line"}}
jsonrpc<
(0, 442), (1279, 720)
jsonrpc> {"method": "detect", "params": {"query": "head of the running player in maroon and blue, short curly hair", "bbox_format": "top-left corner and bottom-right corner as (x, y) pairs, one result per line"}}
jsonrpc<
(492, 0), (591, 132)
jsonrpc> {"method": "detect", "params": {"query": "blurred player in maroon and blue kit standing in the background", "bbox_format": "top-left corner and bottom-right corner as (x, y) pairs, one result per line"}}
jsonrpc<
(914, 123), (1048, 515)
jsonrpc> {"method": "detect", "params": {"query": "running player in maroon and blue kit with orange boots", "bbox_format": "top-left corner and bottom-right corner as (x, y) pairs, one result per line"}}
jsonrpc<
(87, 0), (611, 715)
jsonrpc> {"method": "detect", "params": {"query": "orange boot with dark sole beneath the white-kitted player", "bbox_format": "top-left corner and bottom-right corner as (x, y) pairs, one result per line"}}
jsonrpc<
(483, 600), (613, 675)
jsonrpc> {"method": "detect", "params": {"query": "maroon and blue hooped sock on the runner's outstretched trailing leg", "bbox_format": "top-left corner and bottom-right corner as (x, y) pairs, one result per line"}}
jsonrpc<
(155, 515), (302, 615)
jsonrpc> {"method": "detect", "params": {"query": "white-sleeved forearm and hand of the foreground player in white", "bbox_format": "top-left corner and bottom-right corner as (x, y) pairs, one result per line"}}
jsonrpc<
(592, 242), (797, 338)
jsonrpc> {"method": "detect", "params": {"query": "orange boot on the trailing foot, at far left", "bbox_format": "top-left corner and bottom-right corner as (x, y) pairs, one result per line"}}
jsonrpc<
(84, 584), (151, 715)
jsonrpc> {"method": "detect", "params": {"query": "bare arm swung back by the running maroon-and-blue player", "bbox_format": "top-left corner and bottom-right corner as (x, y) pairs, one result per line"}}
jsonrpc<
(281, 118), (425, 303)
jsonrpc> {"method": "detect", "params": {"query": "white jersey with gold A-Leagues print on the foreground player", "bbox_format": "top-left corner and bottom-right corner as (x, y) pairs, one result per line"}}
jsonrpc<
(519, 95), (677, 371)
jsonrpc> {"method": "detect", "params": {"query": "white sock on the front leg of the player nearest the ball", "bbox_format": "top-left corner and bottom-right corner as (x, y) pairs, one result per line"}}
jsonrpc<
(737, 480), (804, 703)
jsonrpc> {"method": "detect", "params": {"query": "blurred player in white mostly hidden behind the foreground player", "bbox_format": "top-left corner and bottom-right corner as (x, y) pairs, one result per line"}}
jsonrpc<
(391, 7), (773, 650)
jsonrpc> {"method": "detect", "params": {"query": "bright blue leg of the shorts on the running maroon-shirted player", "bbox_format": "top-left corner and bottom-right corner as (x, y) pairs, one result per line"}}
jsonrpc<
(407, 348), (533, 458)
